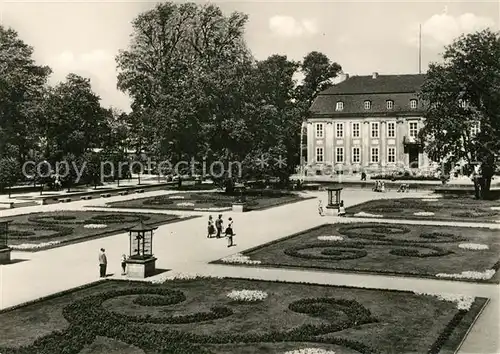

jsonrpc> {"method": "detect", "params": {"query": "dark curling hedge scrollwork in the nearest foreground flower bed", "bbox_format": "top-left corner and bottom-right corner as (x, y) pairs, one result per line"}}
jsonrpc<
(1, 285), (377, 354)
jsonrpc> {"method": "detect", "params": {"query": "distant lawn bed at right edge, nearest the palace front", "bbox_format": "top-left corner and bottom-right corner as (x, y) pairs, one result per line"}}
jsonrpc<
(346, 195), (500, 223)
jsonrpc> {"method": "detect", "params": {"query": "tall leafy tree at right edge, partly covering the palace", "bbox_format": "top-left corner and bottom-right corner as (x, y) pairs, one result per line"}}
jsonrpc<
(420, 30), (500, 198)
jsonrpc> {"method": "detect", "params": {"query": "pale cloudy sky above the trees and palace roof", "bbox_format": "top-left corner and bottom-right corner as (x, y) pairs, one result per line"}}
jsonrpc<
(0, 0), (500, 112)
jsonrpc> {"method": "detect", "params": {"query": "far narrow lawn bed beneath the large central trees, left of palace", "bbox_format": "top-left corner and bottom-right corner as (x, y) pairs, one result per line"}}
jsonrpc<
(108, 190), (306, 211)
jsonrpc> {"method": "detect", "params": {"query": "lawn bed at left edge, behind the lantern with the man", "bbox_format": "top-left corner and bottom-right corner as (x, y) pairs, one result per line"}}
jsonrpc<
(2, 211), (188, 251)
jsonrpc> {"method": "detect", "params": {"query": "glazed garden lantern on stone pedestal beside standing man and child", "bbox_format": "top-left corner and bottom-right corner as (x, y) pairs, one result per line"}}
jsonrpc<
(126, 220), (158, 278)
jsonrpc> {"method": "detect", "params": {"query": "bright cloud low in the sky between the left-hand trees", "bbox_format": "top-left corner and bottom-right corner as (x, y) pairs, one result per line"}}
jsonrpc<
(47, 49), (130, 111)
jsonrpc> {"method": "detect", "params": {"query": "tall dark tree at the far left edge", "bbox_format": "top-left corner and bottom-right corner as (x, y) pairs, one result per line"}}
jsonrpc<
(0, 25), (51, 160)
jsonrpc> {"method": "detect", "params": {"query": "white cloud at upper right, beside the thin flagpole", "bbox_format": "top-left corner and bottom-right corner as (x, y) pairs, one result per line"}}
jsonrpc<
(409, 11), (495, 48)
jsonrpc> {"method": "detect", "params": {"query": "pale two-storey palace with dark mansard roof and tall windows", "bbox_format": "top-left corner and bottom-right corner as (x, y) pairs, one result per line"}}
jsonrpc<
(305, 73), (430, 175)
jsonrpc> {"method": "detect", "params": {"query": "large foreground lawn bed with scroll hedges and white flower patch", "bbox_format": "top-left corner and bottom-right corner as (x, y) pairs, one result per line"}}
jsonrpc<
(0, 278), (487, 354)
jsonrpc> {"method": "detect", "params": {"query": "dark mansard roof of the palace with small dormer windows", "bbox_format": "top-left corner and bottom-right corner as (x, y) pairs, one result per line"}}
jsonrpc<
(310, 74), (425, 116)
